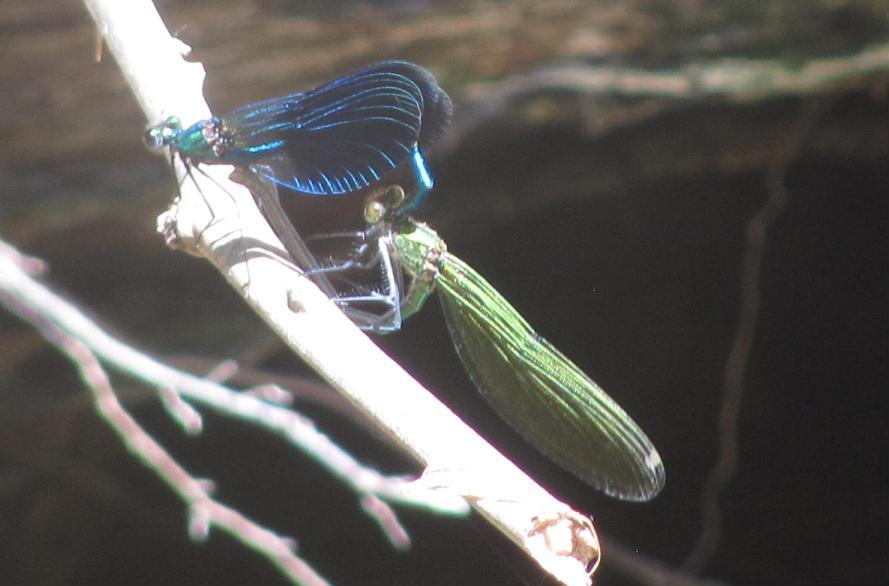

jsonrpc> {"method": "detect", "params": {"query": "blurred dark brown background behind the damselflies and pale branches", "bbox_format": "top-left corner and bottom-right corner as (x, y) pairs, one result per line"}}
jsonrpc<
(0, 0), (889, 586)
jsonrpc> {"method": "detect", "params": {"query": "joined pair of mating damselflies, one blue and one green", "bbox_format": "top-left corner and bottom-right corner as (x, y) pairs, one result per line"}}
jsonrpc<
(146, 61), (664, 500)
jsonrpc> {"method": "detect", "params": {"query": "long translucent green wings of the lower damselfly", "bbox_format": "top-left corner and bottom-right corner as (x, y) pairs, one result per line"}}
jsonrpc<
(436, 253), (664, 501)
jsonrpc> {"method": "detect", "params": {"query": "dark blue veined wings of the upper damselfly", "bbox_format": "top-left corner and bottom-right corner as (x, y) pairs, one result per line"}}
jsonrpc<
(216, 61), (452, 195)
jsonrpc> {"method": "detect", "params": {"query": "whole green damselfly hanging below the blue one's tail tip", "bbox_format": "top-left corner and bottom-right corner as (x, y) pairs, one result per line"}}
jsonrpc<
(322, 187), (664, 501)
